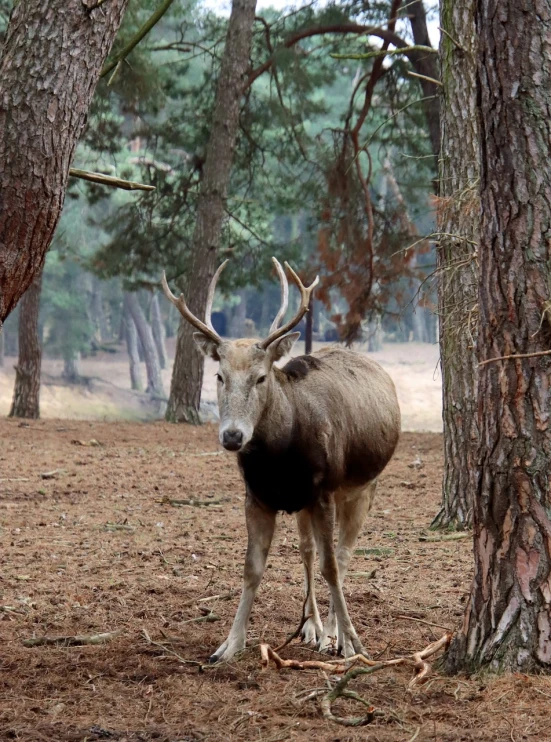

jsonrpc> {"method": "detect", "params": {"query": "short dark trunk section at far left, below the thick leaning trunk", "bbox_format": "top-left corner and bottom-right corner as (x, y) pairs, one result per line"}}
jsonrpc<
(9, 273), (42, 420)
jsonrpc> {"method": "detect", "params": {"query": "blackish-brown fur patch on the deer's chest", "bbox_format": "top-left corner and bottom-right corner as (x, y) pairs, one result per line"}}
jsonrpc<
(238, 439), (324, 513)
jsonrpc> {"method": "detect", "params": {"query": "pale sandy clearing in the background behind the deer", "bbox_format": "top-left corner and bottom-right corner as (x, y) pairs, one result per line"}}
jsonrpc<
(0, 338), (442, 431)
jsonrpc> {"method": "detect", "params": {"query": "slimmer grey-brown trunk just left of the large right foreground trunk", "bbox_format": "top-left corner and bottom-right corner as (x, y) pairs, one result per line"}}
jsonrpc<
(433, 0), (480, 529)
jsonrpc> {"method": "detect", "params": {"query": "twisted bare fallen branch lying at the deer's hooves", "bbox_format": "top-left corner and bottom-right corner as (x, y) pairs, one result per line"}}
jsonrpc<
(260, 631), (452, 727)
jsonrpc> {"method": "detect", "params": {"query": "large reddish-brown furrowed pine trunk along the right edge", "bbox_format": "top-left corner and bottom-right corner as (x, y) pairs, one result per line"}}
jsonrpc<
(448, 0), (551, 672)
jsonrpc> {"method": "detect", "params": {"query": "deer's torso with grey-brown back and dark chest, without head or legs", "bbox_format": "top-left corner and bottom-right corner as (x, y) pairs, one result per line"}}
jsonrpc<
(238, 348), (400, 513)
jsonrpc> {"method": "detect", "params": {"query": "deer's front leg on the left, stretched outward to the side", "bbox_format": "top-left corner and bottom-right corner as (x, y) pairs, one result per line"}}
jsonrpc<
(209, 492), (276, 662)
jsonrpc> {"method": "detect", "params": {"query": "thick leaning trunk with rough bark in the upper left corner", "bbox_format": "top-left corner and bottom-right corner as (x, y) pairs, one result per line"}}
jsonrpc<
(0, 0), (128, 324)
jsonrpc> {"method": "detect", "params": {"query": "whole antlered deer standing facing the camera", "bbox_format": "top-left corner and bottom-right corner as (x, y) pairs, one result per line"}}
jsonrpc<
(161, 258), (401, 663)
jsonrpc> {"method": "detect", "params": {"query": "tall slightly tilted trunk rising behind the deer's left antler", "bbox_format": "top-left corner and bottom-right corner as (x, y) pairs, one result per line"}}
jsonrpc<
(166, 0), (256, 424)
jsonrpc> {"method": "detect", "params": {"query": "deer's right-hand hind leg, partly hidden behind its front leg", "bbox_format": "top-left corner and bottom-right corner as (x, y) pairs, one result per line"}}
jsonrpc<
(319, 480), (377, 657)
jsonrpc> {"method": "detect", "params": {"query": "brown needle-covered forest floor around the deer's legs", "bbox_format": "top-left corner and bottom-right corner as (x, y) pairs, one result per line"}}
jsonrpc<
(0, 419), (551, 742)
